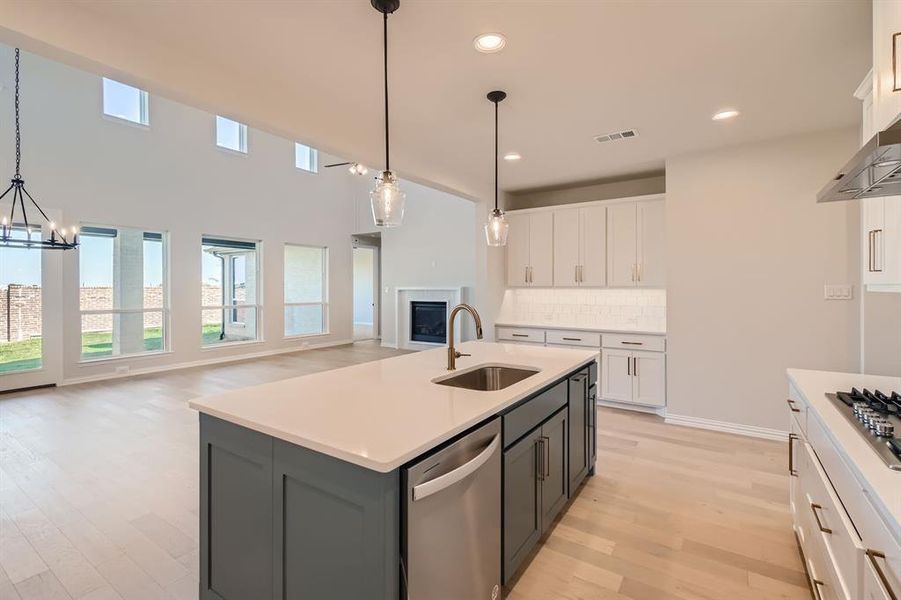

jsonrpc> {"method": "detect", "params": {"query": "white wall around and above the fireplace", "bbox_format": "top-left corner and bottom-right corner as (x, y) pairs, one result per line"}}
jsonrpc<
(353, 177), (482, 346)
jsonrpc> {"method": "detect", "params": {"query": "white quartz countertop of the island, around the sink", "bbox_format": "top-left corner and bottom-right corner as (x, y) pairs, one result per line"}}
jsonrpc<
(189, 342), (598, 473)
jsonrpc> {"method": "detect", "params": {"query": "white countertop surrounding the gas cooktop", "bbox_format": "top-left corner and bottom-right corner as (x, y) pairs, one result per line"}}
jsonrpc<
(788, 369), (901, 531)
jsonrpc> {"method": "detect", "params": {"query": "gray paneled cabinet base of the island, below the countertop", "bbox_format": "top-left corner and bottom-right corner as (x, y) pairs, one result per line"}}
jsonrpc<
(193, 342), (597, 600)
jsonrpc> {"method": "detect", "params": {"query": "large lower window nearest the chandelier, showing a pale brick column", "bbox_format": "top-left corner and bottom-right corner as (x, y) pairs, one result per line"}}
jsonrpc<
(78, 226), (169, 360)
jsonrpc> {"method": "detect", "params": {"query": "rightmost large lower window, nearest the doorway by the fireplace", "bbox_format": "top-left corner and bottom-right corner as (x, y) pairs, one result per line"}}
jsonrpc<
(285, 244), (328, 336)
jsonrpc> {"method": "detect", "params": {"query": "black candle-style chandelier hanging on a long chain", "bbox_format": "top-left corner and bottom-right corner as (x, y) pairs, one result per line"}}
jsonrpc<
(0, 48), (78, 250)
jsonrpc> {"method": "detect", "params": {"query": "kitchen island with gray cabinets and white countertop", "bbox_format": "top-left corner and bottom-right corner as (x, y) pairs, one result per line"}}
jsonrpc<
(190, 342), (598, 600)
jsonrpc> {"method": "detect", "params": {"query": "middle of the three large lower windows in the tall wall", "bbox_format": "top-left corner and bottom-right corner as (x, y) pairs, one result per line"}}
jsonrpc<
(201, 235), (261, 346)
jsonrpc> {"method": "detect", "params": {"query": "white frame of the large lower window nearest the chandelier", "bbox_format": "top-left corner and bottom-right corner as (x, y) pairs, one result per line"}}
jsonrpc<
(75, 224), (172, 364)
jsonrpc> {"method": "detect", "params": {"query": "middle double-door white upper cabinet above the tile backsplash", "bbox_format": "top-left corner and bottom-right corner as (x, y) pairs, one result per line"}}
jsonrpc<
(554, 205), (607, 287)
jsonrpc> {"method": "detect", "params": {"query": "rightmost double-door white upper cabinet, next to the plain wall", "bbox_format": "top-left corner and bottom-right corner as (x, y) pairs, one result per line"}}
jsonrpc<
(607, 200), (666, 287)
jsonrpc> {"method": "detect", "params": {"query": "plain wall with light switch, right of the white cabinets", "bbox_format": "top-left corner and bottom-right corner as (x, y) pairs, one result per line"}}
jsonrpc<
(666, 130), (859, 430)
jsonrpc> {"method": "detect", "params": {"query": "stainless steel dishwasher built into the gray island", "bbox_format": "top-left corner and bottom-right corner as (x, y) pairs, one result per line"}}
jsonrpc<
(401, 418), (503, 600)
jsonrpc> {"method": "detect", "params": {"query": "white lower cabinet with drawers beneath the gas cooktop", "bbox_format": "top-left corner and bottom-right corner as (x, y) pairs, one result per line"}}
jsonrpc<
(788, 384), (901, 600)
